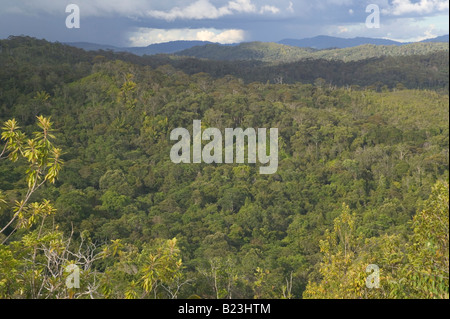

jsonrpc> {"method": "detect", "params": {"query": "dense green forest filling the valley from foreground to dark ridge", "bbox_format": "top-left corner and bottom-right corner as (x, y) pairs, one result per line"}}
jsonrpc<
(0, 37), (449, 299)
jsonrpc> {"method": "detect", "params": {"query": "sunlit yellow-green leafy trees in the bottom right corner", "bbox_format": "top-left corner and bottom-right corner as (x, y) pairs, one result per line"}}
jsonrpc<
(303, 182), (449, 299)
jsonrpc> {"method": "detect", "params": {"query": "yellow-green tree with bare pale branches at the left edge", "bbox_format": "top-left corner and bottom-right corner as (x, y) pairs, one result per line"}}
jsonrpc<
(0, 116), (118, 299)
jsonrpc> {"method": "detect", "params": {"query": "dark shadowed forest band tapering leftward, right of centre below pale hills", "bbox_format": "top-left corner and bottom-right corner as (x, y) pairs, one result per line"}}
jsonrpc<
(167, 52), (449, 92)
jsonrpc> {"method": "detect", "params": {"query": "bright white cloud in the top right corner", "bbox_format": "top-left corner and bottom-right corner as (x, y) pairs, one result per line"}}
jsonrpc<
(382, 0), (449, 16)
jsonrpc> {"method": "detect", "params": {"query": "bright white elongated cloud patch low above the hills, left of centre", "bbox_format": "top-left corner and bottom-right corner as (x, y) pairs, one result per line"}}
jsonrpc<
(129, 28), (246, 47)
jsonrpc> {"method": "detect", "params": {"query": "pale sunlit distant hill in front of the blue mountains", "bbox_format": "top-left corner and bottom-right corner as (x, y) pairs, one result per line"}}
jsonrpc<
(176, 42), (449, 63)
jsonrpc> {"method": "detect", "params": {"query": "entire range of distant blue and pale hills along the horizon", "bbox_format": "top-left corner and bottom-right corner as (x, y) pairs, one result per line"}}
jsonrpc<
(67, 35), (449, 62)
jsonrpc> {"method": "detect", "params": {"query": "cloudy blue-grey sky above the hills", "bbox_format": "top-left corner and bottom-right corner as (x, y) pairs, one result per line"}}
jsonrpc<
(0, 0), (449, 47)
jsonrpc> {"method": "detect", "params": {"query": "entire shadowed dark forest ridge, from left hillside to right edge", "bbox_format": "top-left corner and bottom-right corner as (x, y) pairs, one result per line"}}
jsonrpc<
(0, 37), (449, 95)
